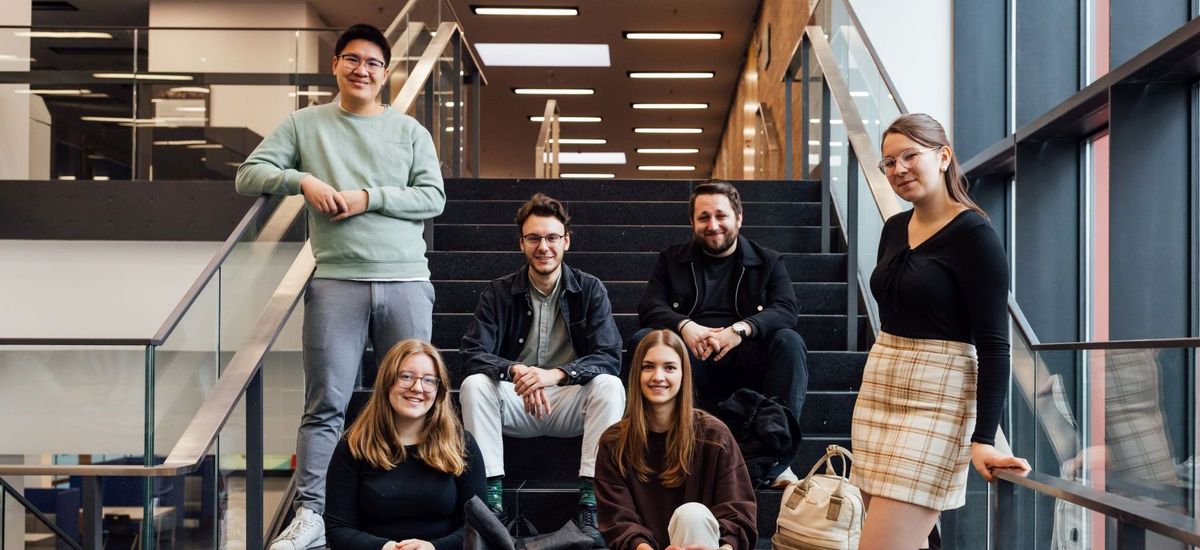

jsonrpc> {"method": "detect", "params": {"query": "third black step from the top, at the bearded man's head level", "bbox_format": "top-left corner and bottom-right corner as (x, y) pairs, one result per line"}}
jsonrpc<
(433, 223), (840, 252)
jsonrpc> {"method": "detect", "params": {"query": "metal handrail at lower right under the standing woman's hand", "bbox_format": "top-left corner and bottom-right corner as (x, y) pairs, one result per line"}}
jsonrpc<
(994, 470), (1200, 549)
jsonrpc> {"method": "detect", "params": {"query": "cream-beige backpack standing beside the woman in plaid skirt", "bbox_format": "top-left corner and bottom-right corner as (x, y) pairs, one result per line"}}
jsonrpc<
(770, 446), (866, 550)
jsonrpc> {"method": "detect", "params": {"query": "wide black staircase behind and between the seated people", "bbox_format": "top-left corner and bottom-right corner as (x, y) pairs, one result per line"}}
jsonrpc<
(350, 179), (870, 548)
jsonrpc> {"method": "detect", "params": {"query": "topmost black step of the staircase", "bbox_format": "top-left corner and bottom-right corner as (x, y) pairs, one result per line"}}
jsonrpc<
(445, 178), (821, 202)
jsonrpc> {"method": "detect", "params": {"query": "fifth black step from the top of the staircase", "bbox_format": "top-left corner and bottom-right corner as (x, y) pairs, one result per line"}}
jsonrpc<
(433, 280), (846, 315)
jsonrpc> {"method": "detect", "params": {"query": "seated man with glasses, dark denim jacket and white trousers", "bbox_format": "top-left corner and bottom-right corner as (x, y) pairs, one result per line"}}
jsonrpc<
(458, 193), (625, 545)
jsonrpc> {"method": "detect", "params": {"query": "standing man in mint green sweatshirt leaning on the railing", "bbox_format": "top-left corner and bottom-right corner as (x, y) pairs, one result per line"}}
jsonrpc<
(236, 24), (445, 550)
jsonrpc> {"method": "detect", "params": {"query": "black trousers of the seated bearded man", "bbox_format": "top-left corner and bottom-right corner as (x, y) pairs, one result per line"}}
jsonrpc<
(620, 329), (809, 419)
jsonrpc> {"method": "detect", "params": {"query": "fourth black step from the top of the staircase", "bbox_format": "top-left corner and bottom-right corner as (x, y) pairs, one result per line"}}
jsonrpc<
(427, 250), (846, 282)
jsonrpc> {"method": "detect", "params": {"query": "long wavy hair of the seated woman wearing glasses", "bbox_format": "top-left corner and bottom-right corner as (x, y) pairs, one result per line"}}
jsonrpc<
(346, 340), (467, 476)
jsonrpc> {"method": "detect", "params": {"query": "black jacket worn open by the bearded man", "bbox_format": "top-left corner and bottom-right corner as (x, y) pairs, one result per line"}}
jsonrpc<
(637, 235), (799, 340)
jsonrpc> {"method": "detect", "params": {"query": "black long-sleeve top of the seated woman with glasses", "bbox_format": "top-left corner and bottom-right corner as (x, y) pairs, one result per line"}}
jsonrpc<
(325, 434), (487, 550)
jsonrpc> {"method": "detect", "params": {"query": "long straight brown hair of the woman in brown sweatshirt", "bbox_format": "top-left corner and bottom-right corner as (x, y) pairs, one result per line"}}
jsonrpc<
(607, 329), (697, 488)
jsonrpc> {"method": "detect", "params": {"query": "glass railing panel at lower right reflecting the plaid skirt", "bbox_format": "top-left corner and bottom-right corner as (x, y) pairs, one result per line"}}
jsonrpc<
(1036, 348), (1196, 548)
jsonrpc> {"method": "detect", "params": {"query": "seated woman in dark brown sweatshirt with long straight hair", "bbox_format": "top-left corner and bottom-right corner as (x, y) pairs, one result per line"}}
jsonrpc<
(595, 330), (758, 550)
